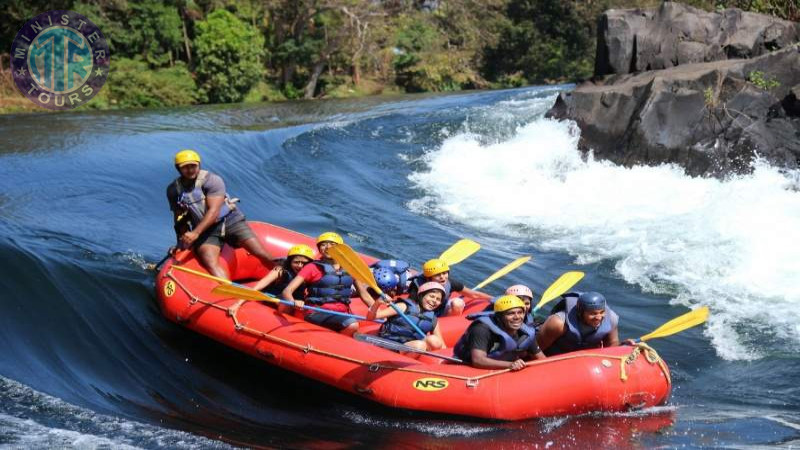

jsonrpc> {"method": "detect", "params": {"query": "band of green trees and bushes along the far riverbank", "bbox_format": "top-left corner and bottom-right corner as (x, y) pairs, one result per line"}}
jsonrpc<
(0, 0), (800, 112)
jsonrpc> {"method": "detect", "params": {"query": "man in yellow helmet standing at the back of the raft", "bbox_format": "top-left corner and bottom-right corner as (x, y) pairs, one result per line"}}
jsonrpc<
(167, 150), (275, 278)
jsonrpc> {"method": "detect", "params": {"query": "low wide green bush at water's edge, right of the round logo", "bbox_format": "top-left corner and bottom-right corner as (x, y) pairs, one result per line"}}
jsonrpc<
(106, 58), (198, 108)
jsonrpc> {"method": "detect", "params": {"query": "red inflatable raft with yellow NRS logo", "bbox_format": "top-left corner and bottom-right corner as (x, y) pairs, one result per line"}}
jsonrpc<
(156, 222), (671, 420)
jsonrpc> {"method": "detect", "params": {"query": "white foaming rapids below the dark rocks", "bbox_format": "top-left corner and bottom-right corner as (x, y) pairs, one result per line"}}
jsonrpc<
(408, 114), (800, 359)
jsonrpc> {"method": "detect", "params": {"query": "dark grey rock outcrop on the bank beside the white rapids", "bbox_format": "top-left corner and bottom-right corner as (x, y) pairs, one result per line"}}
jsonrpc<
(548, 3), (800, 176)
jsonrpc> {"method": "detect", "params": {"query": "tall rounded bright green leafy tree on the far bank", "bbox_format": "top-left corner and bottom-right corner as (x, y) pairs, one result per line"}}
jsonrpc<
(195, 9), (264, 103)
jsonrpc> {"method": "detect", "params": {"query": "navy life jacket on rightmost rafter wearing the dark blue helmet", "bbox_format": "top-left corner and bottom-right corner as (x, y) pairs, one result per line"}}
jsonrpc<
(545, 293), (619, 356)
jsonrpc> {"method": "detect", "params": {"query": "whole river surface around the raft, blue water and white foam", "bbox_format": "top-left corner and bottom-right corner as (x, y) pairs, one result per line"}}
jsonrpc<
(0, 87), (800, 449)
